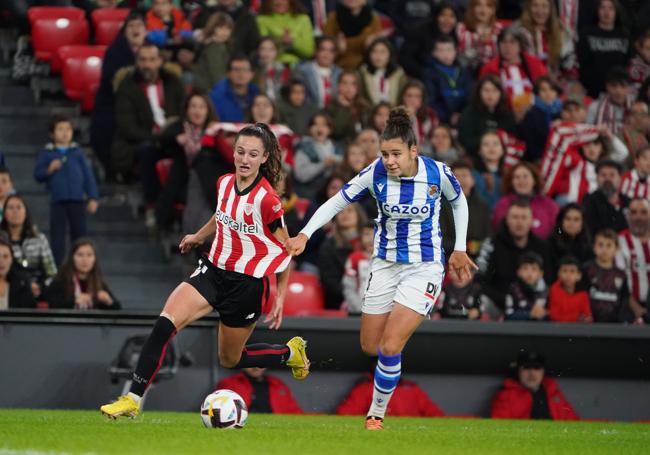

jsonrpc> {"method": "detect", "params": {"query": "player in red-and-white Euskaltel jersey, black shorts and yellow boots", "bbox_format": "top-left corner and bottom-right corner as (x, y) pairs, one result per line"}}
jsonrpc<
(101, 123), (309, 418)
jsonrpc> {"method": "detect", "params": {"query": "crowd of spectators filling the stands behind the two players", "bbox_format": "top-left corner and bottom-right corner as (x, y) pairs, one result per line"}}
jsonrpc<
(0, 0), (650, 324)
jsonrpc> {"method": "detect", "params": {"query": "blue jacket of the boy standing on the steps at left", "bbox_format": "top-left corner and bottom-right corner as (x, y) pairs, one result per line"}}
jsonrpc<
(34, 143), (98, 203)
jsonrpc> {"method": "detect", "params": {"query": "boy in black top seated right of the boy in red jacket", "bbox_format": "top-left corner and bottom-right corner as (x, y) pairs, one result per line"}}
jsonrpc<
(582, 229), (630, 322)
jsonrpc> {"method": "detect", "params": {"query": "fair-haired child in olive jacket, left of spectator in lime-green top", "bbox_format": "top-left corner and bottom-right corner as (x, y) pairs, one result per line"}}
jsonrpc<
(194, 13), (235, 91)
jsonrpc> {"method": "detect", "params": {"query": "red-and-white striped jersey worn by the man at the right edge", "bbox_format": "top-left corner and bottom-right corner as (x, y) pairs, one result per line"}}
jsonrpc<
(616, 229), (650, 302)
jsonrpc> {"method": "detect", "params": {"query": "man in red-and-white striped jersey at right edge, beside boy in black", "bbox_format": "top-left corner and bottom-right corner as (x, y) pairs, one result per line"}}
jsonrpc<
(616, 198), (650, 323)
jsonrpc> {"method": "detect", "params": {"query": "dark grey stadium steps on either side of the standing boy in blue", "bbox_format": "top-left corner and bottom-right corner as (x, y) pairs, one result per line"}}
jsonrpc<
(0, 61), (183, 311)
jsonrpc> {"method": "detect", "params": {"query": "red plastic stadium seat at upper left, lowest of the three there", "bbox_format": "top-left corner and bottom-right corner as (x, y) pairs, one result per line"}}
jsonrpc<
(57, 46), (106, 109)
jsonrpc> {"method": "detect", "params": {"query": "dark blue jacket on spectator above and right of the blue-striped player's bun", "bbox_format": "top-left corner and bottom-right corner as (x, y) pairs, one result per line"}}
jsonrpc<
(422, 57), (472, 123)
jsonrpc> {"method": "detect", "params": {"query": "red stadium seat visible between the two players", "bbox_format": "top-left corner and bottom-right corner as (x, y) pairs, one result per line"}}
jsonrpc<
(284, 272), (325, 316)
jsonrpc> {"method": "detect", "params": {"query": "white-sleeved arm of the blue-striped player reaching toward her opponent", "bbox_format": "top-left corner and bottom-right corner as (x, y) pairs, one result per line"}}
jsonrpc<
(284, 160), (379, 256)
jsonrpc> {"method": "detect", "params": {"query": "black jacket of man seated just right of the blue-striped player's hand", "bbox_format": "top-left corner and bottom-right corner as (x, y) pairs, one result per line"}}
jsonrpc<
(477, 224), (550, 309)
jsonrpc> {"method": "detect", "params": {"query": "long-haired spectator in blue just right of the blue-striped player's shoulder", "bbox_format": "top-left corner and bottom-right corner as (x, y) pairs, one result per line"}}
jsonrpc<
(472, 131), (505, 211)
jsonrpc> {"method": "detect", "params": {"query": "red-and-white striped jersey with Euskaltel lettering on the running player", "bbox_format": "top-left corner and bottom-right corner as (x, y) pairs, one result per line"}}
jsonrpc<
(208, 174), (291, 278)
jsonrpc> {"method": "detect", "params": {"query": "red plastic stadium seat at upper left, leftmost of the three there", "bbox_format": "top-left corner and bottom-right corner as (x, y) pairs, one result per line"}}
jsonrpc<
(32, 18), (88, 73)
